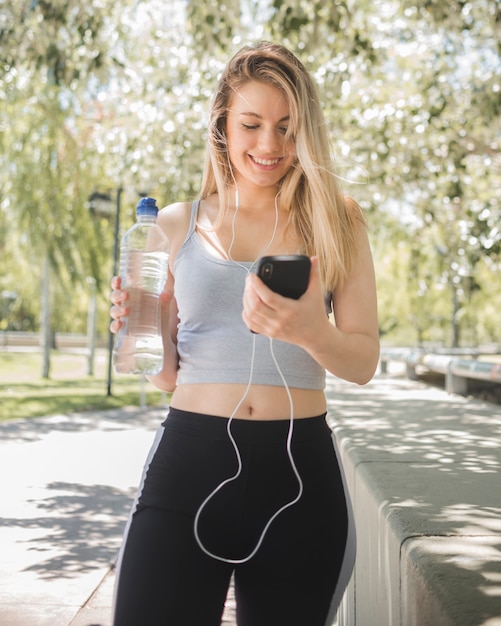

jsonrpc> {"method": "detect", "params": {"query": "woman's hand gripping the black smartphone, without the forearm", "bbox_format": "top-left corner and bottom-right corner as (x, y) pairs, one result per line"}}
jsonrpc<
(242, 257), (329, 347)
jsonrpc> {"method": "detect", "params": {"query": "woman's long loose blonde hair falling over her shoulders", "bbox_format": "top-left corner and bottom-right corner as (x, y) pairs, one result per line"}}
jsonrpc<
(200, 42), (364, 291)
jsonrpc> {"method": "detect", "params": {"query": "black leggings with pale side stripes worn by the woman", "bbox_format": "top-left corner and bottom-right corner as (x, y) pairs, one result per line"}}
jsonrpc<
(113, 408), (354, 626)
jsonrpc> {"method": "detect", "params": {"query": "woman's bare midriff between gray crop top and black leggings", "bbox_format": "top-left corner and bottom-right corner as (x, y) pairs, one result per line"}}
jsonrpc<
(170, 383), (326, 420)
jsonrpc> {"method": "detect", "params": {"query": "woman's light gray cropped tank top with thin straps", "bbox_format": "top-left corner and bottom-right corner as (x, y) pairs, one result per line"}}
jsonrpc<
(173, 201), (325, 389)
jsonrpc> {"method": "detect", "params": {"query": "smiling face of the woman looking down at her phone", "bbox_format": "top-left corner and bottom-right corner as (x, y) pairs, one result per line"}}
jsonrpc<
(226, 81), (296, 188)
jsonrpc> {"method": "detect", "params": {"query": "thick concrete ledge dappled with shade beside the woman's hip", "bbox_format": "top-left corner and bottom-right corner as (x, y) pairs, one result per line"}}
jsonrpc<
(328, 376), (501, 626)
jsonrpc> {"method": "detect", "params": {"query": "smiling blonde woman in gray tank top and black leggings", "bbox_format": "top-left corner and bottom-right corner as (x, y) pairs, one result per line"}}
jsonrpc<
(111, 42), (379, 626)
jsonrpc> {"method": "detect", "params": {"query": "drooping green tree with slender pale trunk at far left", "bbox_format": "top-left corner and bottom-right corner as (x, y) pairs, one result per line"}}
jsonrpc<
(0, 0), (129, 377)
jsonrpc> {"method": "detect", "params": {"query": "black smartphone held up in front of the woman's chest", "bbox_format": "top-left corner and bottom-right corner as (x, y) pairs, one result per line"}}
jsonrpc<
(257, 254), (311, 300)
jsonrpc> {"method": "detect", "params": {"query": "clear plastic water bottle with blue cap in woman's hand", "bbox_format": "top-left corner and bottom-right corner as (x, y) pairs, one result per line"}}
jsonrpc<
(113, 198), (169, 374)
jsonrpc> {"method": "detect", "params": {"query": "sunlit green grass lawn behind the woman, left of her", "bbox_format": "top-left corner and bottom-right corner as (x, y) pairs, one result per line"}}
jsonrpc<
(0, 350), (166, 422)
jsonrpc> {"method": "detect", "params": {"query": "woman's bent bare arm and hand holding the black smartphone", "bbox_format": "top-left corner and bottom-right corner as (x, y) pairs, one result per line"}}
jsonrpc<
(243, 219), (379, 384)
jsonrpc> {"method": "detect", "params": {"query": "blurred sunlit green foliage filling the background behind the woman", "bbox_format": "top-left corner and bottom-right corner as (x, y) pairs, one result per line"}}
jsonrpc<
(0, 0), (501, 356)
